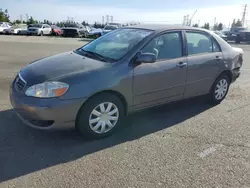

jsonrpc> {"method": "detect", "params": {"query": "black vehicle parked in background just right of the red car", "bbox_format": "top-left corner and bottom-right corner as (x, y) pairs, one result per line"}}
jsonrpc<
(62, 23), (88, 37)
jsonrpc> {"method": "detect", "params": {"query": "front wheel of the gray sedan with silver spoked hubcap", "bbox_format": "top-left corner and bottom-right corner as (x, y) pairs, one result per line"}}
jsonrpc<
(75, 93), (125, 139)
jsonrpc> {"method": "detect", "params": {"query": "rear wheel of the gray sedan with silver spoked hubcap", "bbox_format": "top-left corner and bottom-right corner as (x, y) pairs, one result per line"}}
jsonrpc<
(209, 74), (231, 105)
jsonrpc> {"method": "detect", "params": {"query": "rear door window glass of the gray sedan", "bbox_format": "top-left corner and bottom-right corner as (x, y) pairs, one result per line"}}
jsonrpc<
(186, 32), (213, 55)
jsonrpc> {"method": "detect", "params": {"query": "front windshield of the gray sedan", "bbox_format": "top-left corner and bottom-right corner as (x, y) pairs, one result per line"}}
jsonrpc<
(78, 29), (152, 62)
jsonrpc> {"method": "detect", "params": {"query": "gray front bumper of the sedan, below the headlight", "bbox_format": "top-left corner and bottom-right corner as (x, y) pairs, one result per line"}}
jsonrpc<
(10, 85), (85, 130)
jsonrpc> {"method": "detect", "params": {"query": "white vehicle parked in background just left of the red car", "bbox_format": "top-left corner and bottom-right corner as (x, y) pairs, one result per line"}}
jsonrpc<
(27, 24), (52, 36)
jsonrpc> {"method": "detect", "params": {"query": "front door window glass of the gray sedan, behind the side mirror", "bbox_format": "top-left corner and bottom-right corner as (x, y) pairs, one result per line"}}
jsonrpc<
(142, 32), (182, 60)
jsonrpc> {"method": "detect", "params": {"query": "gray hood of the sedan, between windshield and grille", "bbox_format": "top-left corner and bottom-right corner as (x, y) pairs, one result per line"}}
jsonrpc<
(20, 51), (107, 85)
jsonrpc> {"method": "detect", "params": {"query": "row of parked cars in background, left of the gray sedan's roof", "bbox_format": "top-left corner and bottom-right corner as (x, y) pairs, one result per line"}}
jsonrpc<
(0, 22), (120, 38)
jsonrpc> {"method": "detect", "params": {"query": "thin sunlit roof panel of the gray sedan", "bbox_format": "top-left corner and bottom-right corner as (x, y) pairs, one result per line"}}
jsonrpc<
(126, 24), (208, 31)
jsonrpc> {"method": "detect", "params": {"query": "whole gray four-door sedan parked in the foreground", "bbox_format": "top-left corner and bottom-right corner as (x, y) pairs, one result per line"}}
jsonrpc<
(10, 25), (243, 138)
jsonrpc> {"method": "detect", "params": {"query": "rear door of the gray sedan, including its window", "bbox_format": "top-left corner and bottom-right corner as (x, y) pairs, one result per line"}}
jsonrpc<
(185, 31), (224, 97)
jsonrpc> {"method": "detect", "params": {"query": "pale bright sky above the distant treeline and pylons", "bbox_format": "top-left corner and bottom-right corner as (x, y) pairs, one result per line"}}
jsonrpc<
(0, 0), (250, 25)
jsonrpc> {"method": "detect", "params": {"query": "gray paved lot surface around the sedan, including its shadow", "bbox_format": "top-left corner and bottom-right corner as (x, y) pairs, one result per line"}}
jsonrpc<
(0, 36), (250, 188)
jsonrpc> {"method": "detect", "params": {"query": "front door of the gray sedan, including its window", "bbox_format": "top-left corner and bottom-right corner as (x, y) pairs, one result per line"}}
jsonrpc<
(133, 31), (187, 108)
